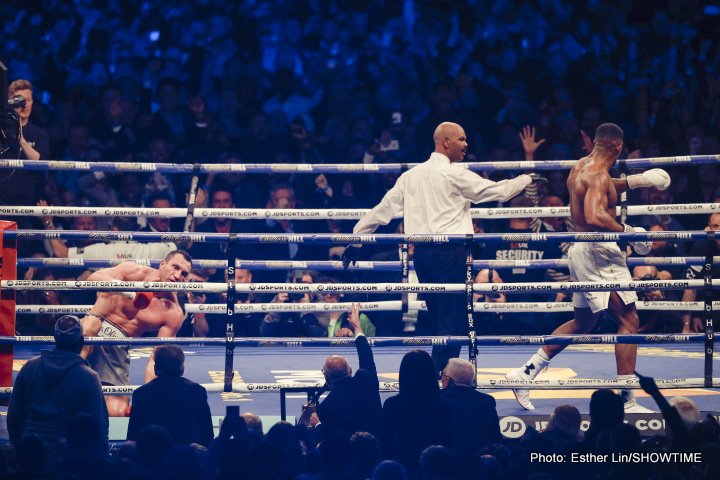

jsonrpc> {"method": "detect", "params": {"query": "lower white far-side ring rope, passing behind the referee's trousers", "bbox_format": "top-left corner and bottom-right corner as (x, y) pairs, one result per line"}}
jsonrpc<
(15, 300), (720, 315)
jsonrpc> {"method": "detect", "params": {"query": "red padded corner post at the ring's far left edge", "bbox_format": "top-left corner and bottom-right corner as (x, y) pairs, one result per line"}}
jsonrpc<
(0, 220), (17, 405)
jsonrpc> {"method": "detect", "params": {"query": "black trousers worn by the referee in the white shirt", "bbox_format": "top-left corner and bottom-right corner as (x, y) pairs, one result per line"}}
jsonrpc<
(413, 244), (468, 372)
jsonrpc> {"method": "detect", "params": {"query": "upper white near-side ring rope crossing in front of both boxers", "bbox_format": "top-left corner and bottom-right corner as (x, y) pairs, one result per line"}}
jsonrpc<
(0, 279), (720, 294)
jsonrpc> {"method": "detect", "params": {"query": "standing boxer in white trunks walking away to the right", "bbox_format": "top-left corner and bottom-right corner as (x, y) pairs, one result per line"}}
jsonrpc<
(506, 123), (670, 413)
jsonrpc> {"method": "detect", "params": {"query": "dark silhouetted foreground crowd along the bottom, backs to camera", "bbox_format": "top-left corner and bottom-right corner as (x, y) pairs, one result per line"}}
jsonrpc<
(0, 342), (720, 480)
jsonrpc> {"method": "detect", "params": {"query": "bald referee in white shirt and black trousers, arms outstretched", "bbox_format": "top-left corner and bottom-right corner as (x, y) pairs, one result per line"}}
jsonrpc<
(343, 122), (532, 373)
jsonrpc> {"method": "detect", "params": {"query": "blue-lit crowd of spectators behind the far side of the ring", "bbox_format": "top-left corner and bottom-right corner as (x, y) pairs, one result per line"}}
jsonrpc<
(0, 0), (720, 335)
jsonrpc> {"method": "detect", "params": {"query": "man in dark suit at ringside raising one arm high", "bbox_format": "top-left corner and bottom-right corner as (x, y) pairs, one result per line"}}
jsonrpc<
(317, 303), (382, 437)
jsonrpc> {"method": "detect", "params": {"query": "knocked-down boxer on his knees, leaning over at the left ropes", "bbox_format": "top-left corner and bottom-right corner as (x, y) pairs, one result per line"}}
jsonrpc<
(81, 250), (192, 417)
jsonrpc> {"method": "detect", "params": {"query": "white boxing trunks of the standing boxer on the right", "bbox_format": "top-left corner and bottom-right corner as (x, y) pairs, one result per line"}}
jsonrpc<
(568, 242), (637, 313)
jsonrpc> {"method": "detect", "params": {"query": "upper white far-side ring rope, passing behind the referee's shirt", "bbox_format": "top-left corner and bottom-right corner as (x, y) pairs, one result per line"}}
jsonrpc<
(0, 203), (720, 220)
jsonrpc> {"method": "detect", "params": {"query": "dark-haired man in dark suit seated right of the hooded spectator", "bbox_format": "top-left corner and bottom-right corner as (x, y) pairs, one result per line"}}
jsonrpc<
(127, 345), (213, 447)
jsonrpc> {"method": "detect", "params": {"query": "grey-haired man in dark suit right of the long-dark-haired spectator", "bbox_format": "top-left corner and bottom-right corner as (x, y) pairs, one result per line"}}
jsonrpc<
(440, 358), (502, 452)
